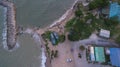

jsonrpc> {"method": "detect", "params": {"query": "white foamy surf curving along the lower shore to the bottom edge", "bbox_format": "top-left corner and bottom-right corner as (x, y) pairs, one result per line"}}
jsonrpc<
(24, 28), (48, 67)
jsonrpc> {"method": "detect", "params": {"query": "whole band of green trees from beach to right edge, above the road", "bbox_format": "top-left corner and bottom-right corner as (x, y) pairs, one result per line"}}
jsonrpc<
(65, 7), (119, 41)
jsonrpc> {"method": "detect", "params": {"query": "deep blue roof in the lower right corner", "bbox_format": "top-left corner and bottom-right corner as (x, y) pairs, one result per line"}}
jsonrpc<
(110, 48), (120, 67)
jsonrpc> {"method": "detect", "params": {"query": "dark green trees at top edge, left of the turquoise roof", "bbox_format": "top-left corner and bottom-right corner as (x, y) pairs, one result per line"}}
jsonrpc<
(89, 0), (109, 10)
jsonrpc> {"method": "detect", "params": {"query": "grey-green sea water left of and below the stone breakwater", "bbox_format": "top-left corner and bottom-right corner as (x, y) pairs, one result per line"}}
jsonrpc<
(0, 6), (42, 67)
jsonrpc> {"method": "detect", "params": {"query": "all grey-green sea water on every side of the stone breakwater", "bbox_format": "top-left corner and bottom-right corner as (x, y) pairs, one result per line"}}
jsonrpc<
(0, 0), (74, 67)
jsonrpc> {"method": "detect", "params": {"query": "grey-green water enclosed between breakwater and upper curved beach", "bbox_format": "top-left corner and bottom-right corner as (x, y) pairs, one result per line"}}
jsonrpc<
(10, 0), (75, 27)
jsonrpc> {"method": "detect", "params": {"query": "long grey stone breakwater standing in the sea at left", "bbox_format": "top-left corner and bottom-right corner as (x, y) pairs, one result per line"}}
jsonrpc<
(0, 0), (16, 50)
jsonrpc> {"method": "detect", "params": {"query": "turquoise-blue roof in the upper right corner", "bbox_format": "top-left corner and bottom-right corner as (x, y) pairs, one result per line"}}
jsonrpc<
(109, 2), (120, 19)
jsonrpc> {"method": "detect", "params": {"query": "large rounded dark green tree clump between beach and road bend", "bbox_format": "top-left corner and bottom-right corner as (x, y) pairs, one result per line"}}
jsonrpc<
(65, 18), (93, 41)
